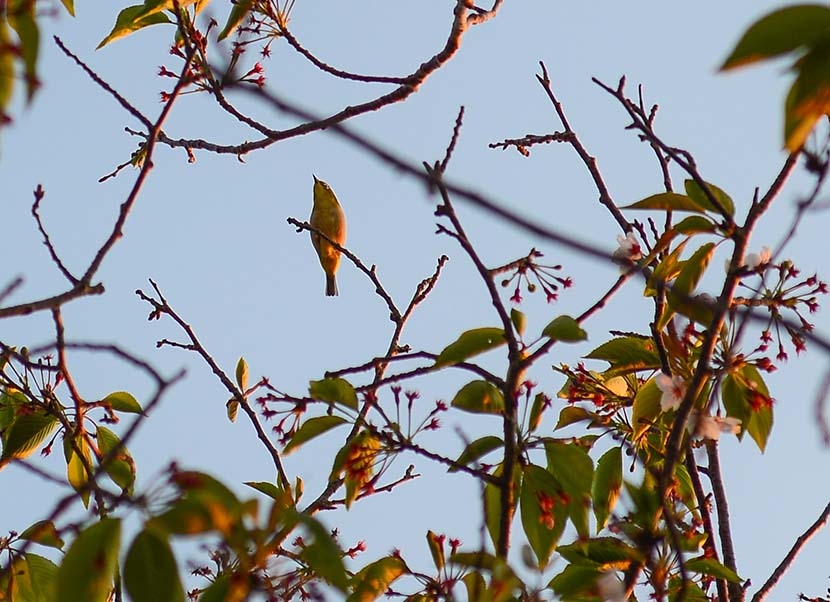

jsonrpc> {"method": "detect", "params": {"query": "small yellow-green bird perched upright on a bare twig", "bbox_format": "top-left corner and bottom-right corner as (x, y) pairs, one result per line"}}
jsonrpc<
(309, 174), (346, 297)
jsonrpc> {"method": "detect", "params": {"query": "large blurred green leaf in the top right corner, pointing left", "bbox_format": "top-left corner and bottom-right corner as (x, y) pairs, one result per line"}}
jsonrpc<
(721, 4), (830, 71)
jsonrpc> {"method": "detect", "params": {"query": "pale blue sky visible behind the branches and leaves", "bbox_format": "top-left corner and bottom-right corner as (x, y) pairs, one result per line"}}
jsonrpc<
(0, 0), (830, 600)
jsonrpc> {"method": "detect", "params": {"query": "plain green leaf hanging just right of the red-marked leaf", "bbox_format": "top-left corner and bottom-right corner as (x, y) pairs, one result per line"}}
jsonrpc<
(545, 440), (594, 537)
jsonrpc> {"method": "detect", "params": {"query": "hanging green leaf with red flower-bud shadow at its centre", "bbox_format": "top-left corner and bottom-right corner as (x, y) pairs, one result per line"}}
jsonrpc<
(520, 465), (568, 569)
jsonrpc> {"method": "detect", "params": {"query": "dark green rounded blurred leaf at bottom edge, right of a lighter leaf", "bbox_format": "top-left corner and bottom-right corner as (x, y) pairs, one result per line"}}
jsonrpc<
(124, 529), (184, 602)
